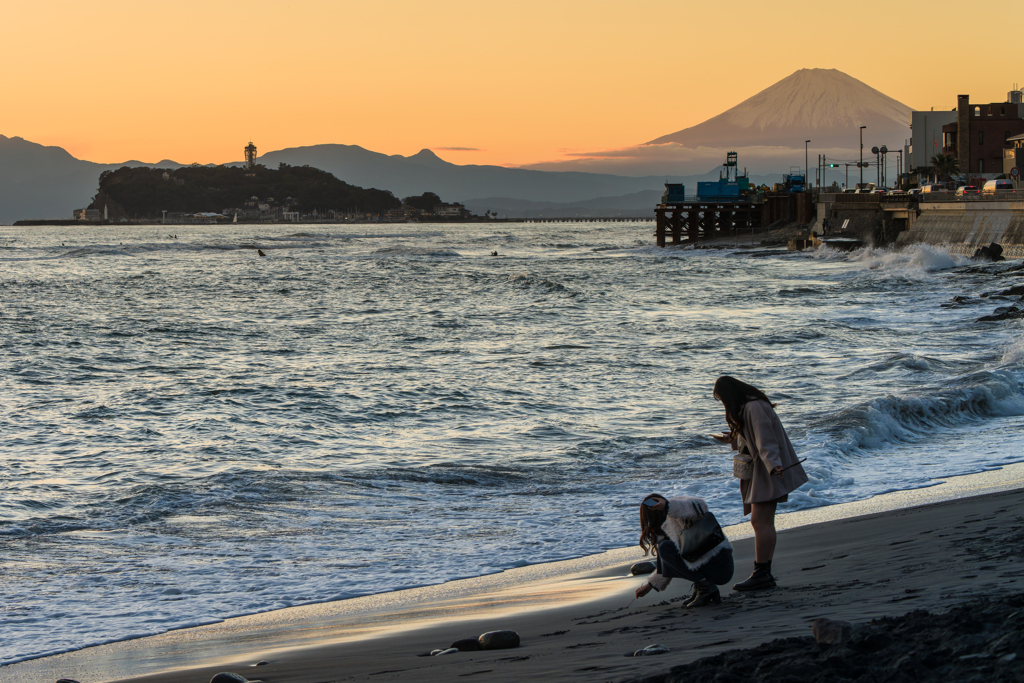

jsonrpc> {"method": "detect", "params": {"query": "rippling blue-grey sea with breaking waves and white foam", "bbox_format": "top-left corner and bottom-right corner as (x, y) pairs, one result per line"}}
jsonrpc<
(0, 223), (1024, 664)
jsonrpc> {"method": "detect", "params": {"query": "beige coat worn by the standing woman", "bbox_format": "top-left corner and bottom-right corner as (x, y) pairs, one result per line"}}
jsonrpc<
(739, 400), (807, 507)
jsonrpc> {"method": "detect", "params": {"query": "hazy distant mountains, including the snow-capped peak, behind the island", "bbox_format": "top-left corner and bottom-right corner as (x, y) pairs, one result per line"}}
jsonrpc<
(0, 69), (910, 223)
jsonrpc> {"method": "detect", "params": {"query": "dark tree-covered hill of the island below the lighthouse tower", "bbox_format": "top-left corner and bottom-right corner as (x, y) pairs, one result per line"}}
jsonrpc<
(89, 164), (401, 218)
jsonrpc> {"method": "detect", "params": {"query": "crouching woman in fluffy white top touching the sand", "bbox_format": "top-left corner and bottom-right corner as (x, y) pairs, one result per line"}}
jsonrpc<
(636, 494), (733, 607)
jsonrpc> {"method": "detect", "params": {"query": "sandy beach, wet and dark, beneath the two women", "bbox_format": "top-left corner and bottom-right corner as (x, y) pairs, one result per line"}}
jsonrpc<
(0, 465), (1024, 683)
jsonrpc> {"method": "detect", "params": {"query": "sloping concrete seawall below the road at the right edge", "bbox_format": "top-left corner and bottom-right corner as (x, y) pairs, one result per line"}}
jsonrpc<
(896, 202), (1024, 258)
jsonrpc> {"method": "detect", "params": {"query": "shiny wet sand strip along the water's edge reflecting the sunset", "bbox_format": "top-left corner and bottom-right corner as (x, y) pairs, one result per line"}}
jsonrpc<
(0, 463), (1024, 683)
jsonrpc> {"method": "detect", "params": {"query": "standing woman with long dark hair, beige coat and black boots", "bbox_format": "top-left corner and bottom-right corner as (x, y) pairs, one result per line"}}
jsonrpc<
(713, 377), (807, 591)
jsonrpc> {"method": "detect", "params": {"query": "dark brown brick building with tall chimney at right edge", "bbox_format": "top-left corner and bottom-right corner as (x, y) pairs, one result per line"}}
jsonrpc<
(942, 95), (1024, 176)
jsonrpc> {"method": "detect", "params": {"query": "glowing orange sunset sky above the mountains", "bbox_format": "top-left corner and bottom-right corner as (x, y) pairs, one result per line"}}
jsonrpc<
(0, 0), (1024, 165)
